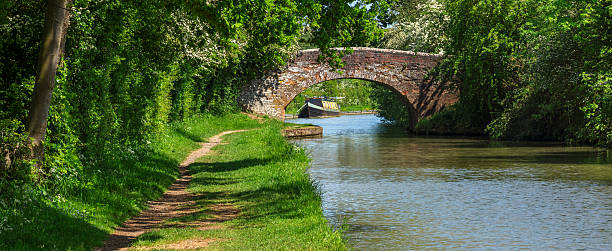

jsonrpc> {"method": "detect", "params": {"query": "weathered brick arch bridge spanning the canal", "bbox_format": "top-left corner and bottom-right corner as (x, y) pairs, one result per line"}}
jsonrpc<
(238, 47), (457, 126)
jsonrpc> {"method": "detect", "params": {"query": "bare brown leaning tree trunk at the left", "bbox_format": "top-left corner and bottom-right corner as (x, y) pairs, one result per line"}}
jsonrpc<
(26, 0), (70, 167)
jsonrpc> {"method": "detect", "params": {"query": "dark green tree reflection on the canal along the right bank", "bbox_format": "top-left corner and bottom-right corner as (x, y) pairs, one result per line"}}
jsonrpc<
(320, 135), (612, 184)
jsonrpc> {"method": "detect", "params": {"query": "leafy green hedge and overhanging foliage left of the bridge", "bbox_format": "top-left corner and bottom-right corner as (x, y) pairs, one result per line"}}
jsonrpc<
(0, 0), (388, 186)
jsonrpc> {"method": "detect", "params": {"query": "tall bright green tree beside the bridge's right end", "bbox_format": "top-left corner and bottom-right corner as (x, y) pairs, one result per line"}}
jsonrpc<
(443, 0), (524, 127)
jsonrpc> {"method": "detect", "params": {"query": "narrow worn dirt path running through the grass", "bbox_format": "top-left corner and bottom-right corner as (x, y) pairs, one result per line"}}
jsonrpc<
(96, 130), (247, 250)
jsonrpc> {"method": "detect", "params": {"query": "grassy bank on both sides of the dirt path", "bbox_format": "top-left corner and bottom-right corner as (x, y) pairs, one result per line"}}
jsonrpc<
(0, 114), (342, 250)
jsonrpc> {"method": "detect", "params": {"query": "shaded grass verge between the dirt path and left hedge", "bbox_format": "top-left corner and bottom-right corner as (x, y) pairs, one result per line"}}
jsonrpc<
(0, 114), (261, 250)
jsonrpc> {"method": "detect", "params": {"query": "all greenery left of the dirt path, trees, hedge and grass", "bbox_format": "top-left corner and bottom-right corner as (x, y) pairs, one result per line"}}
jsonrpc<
(0, 0), (387, 250)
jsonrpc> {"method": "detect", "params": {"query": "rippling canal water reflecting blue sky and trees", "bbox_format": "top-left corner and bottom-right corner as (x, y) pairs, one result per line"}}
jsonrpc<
(287, 115), (612, 250)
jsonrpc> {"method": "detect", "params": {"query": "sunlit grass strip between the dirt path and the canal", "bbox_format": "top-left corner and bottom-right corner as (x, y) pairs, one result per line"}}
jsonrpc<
(130, 121), (346, 250)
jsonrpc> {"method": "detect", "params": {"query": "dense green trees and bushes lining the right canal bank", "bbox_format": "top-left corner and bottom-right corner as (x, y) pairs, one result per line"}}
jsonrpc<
(379, 0), (612, 146)
